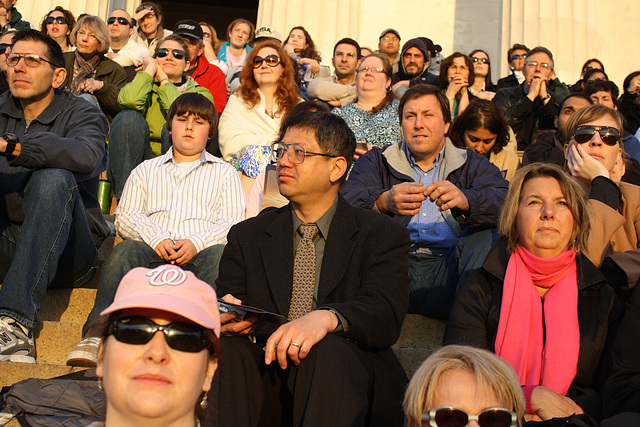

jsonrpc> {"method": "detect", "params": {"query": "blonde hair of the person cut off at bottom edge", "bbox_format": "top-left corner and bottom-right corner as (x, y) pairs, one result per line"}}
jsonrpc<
(403, 345), (526, 427)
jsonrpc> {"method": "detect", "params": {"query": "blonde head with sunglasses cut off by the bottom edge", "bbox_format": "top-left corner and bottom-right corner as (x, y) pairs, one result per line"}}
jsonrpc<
(404, 345), (525, 427)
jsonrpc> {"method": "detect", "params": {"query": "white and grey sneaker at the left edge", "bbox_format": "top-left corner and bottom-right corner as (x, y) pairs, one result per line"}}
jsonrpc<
(0, 316), (36, 363)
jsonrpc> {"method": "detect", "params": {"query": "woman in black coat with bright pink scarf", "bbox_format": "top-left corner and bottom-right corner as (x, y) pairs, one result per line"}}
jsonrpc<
(443, 163), (621, 425)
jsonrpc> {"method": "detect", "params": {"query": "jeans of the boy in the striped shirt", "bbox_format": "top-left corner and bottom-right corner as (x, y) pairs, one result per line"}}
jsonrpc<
(82, 240), (224, 336)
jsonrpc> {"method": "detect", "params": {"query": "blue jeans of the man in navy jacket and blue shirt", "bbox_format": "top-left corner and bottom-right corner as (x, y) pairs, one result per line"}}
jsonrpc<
(409, 230), (498, 319)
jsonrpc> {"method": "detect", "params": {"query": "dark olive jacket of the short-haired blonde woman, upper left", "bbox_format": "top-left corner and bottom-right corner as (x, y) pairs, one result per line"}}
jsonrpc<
(62, 52), (127, 122)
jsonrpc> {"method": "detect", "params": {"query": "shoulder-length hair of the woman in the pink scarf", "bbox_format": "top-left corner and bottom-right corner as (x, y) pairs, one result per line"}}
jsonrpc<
(498, 164), (590, 253)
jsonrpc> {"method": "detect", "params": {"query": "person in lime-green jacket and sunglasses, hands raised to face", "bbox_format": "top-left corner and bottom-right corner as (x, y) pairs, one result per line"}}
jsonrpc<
(109, 34), (213, 199)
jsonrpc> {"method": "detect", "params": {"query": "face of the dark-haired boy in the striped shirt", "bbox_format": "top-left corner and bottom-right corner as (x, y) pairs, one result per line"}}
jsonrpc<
(171, 114), (211, 157)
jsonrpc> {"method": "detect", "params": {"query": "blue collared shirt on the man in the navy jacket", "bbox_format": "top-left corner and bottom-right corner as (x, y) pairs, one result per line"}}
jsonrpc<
(405, 145), (457, 254)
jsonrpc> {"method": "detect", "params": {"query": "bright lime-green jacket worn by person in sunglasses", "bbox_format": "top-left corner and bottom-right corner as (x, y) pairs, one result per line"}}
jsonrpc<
(118, 71), (213, 156)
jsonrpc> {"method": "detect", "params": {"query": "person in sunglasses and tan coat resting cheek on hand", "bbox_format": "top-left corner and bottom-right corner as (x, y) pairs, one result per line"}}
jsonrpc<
(565, 105), (640, 297)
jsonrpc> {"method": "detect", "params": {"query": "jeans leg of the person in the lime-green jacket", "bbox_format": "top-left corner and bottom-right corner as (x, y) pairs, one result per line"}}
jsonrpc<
(107, 110), (153, 200)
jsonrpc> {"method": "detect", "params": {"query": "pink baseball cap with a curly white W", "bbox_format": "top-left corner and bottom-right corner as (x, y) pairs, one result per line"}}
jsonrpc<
(100, 264), (220, 337)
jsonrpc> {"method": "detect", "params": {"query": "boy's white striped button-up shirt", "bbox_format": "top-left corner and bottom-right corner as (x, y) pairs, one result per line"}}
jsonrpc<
(115, 150), (245, 252)
